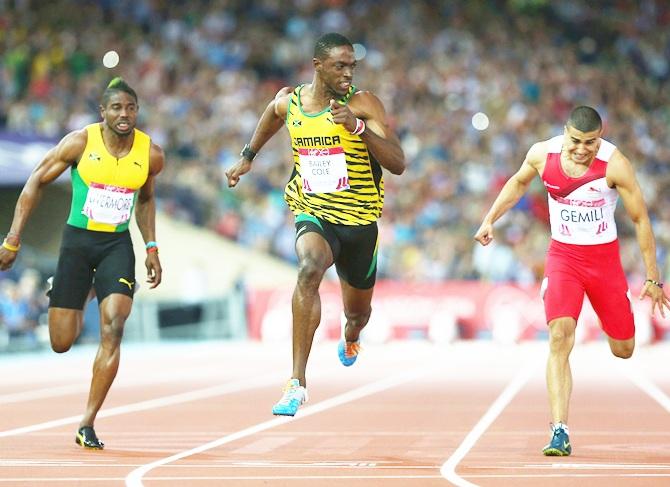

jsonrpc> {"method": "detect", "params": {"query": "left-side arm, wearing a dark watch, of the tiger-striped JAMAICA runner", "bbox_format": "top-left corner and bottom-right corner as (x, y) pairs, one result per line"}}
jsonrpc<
(226, 86), (293, 188)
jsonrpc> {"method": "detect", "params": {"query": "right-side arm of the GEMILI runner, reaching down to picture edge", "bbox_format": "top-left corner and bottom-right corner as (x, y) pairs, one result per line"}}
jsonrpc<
(607, 150), (670, 317)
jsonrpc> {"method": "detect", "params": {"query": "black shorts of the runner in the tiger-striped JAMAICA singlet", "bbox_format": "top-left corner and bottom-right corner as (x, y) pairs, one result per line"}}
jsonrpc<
(295, 213), (378, 289)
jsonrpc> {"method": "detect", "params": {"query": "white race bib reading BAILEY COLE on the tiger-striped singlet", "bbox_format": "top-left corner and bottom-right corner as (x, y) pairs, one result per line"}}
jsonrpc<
(298, 147), (349, 193)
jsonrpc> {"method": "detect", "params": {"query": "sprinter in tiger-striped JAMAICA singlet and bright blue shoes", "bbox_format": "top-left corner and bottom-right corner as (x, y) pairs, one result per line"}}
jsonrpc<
(226, 33), (405, 416)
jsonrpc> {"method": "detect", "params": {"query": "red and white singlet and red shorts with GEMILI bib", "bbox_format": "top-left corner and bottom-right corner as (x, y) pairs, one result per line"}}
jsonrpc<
(541, 134), (635, 340)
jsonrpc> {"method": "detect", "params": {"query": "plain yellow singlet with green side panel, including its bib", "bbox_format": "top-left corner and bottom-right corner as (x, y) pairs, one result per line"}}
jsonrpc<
(67, 123), (151, 232)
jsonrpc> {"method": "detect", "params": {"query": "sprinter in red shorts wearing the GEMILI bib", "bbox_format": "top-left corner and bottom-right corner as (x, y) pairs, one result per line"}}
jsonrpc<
(475, 106), (670, 456)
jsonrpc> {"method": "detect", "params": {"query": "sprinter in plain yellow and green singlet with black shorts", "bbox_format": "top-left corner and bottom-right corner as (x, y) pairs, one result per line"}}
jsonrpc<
(0, 78), (164, 449)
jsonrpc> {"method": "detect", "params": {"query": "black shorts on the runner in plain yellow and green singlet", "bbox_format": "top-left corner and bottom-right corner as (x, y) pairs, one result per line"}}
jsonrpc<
(49, 225), (135, 309)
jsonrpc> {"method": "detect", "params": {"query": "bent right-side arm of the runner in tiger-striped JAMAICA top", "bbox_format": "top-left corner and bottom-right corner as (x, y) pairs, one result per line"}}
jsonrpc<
(330, 91), (405, 174)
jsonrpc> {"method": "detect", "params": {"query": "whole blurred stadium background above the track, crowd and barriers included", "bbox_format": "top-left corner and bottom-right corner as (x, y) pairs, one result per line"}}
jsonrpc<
(0, 0), (670, 352)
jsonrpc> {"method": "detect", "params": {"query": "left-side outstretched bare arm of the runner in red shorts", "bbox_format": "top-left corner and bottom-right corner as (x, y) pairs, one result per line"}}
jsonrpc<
(475, 142), (546, 245)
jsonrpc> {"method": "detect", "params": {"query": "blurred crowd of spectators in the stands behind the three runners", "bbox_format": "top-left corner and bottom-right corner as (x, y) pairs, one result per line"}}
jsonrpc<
(0, 0), (670, 294)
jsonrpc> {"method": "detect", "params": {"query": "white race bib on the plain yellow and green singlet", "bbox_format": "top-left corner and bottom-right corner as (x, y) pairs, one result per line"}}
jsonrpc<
(81, 183), (135, 225)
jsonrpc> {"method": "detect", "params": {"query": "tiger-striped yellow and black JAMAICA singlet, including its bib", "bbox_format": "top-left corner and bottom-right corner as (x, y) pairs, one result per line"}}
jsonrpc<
(284, 85), (384, 225)
